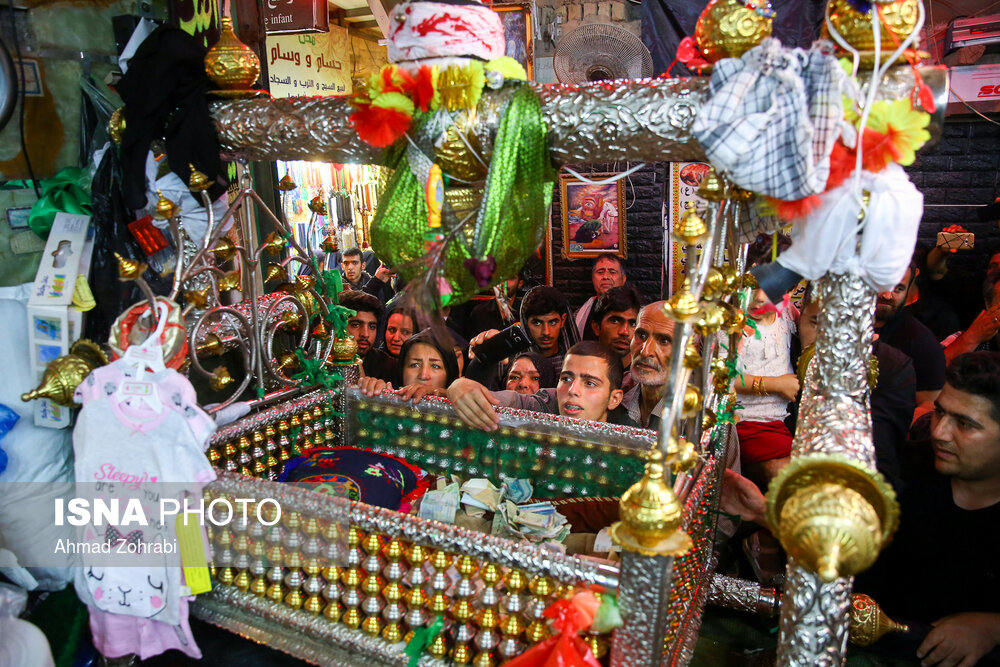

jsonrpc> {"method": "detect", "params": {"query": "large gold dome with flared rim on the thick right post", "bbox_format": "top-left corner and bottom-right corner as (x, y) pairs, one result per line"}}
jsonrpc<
(767, 454), (899, 582)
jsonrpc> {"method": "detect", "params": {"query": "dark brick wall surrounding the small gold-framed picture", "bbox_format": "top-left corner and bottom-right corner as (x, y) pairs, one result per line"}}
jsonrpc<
(550, 162), (666, 308)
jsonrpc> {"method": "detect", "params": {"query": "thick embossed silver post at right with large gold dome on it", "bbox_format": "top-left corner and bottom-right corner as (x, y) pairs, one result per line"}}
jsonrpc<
(768, 274), (899, 666)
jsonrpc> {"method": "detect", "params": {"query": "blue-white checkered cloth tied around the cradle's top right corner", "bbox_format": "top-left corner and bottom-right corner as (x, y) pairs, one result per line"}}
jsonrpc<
(692, 38), (846, 199)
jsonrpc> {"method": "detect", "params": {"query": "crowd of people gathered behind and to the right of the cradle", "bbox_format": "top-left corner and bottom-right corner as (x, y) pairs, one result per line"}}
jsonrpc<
(341, 234), (1000, 665)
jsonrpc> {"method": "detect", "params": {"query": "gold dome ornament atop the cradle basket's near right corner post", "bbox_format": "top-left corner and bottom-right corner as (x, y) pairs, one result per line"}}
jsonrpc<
(611, 447), (692, 556)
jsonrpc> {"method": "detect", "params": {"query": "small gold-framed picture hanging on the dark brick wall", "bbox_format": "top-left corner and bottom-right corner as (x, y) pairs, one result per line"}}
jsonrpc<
(559, 174), (626, 258)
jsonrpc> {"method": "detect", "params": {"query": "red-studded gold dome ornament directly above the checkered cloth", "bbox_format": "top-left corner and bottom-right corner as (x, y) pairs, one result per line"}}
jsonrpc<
(694, 0), (774, 63)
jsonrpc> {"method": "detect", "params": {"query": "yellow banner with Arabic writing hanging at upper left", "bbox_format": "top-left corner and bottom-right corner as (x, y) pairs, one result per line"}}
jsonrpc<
(267, 26), (351, 97)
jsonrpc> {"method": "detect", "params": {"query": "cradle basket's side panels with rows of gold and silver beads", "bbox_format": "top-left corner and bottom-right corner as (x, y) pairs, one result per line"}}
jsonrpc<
(193, 388), (729, 665)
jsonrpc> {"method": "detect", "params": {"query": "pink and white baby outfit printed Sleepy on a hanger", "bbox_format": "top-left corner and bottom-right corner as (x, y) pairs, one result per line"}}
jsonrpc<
(73, 360), (215, 660)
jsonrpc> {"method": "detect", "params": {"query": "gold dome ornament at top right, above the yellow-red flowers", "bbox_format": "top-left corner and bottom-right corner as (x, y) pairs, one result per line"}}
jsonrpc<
(823, 0), (920, 68)
